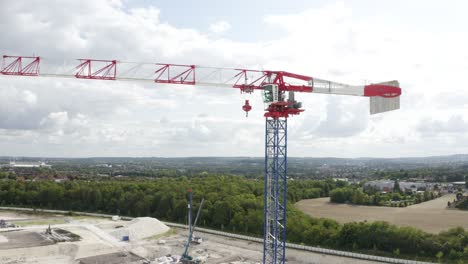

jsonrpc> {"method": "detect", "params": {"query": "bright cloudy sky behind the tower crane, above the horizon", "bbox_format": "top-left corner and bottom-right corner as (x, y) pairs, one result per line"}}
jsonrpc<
(0, 0), (468, 157)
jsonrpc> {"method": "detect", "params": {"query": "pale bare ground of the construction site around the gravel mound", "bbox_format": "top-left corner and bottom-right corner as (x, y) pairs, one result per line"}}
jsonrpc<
(0, 211), (380, 264)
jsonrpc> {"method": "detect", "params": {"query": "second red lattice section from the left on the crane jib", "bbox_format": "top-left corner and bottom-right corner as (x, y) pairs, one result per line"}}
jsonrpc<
(75, 59), (117, 80)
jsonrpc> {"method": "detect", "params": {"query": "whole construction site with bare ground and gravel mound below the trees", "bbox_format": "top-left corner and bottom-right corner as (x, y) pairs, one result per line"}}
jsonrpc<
(0, 208), (386, 264)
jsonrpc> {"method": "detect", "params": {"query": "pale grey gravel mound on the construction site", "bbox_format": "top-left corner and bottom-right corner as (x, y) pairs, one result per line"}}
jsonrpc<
(110, 217), (169, 241)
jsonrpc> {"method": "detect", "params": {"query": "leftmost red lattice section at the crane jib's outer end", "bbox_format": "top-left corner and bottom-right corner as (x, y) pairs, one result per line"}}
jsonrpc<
(0, 55), (41, 76)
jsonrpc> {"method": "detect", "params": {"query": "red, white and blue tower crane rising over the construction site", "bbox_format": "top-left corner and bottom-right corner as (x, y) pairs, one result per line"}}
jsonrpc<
(0, 55), (401, 264)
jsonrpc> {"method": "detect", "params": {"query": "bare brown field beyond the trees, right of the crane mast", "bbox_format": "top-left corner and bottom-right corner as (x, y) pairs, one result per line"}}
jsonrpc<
(295, 194), (468, 233)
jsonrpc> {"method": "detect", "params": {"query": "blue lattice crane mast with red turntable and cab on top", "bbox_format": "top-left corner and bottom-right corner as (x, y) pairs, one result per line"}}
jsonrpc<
(263, 80), (304, 264)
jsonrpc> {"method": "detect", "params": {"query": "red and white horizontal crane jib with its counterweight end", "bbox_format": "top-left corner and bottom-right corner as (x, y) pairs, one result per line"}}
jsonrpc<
(0, 55), (401, 115)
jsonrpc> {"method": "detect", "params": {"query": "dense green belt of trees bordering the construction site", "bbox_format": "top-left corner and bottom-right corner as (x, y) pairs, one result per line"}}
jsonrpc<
(0, 175), (468, 263)
